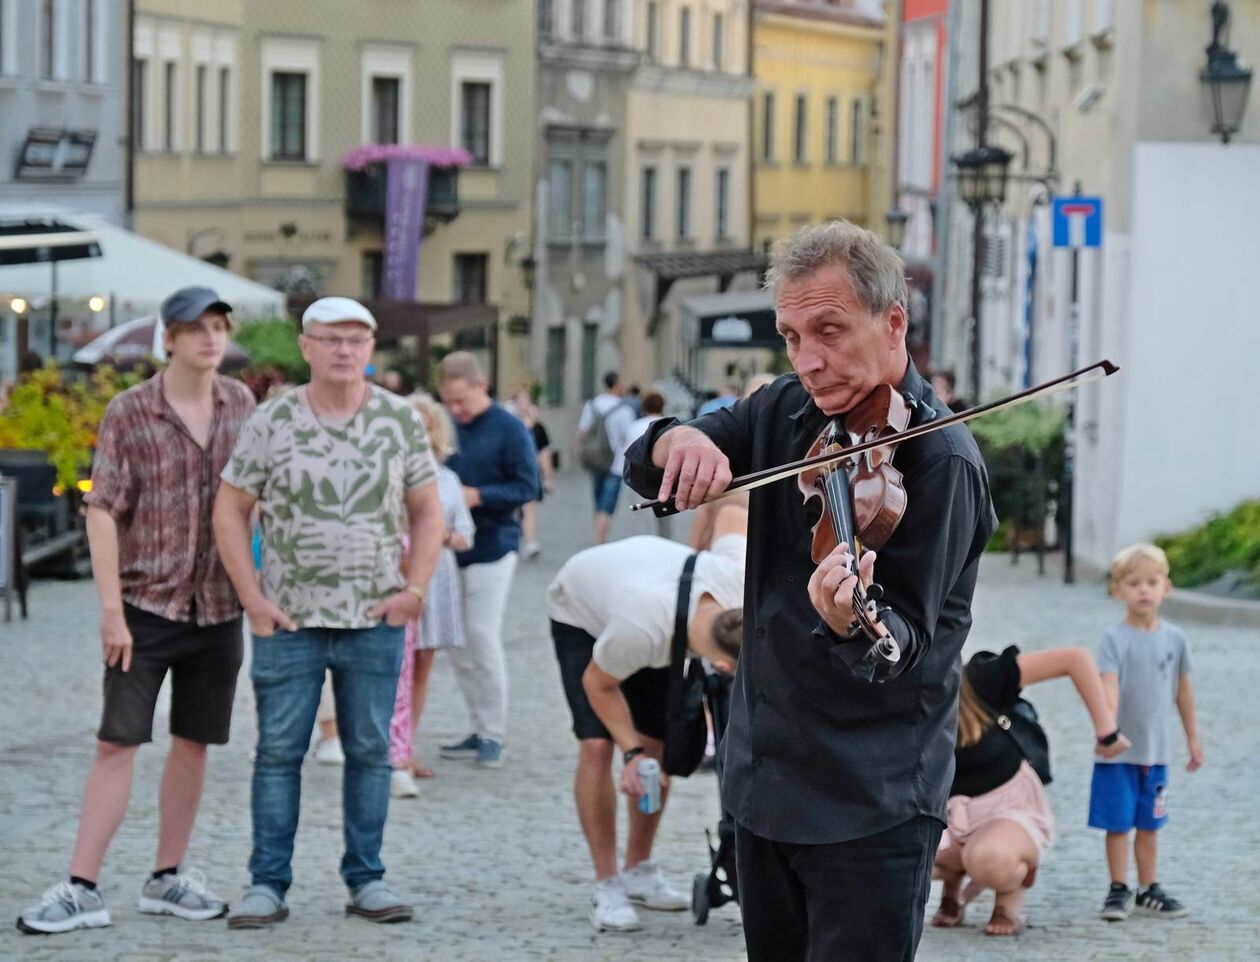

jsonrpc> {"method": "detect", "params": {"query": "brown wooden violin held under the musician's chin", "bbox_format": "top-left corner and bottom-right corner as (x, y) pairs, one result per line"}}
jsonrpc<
(796, 385), (910, 664)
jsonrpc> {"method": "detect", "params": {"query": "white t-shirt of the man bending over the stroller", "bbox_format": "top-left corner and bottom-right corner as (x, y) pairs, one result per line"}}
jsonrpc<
(547, 535), (747, 680)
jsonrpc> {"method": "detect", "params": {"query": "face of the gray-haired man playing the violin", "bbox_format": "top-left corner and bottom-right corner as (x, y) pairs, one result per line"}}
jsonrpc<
(776, 265), (906, 415)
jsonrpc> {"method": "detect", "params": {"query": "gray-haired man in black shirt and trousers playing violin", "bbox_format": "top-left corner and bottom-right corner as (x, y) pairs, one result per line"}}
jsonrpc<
(626, 221), (997, 962)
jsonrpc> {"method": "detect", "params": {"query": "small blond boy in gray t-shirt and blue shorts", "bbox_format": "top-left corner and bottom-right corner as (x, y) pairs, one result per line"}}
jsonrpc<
(1090, 545), (1203, 922)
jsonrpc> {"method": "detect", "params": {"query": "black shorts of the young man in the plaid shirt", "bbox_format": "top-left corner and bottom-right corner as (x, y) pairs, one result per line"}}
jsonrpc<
(96, 605), (244, 745)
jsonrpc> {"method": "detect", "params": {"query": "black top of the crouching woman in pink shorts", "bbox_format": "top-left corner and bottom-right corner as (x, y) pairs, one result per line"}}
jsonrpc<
(949, 644), (1024, 797)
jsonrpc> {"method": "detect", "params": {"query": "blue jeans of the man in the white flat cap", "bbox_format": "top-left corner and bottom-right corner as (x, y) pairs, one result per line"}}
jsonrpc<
(249, 622), (404, 895)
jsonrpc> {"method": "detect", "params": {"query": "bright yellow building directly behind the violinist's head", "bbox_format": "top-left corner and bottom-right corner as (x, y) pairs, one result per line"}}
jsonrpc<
(752, 0), (897, 250)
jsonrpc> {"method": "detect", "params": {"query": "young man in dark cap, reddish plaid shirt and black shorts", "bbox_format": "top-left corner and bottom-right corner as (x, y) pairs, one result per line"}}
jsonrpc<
(18, 287), (253, 933)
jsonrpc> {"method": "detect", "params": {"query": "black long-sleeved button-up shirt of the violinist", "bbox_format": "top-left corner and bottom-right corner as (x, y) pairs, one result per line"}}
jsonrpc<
(626, 364), (997, 843)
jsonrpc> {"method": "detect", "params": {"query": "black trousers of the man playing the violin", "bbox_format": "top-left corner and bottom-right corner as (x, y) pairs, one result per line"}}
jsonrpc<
(735, 816), (944, 962)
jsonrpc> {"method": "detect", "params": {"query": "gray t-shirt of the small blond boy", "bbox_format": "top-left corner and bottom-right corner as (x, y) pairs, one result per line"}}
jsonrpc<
(1099, 622), (1191, 765)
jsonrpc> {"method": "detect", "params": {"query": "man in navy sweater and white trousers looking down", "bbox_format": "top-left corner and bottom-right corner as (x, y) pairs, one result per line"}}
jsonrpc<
(437, 351), (541, 768)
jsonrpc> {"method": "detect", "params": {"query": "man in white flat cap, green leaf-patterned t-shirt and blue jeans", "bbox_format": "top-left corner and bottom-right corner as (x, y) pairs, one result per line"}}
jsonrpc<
(214, 298), (444, 928)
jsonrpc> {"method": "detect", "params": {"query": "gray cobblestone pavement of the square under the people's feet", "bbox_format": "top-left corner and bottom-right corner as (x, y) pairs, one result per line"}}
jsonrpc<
(0, 475), (1260, 962)
